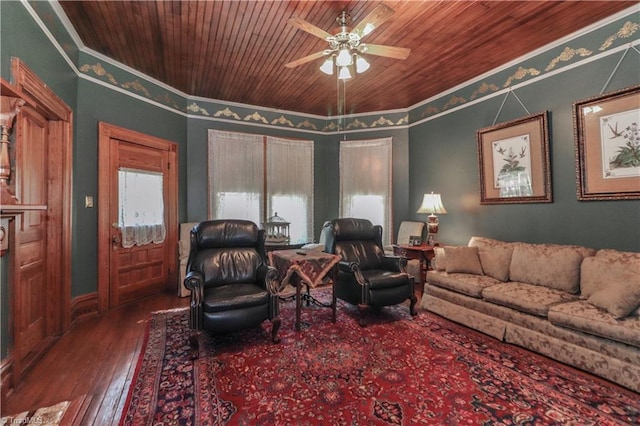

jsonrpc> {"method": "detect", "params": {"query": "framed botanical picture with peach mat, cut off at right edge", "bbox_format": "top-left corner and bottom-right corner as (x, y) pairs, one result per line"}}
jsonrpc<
(573, 86), (640, 201)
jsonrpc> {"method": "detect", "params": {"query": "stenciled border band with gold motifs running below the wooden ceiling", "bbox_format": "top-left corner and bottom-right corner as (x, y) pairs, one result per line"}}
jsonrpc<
(23, 0), (640, 134)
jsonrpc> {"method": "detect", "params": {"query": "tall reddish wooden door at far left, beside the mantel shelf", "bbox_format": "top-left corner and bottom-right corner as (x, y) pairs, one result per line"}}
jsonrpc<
(12, 108), (54, 374)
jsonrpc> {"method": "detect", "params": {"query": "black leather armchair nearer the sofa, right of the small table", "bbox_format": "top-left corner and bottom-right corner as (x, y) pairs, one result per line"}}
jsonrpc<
(325, 218), (418, 325)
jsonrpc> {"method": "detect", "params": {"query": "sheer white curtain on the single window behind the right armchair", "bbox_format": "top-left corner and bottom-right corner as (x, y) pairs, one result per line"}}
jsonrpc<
(340, 138), (392, 245)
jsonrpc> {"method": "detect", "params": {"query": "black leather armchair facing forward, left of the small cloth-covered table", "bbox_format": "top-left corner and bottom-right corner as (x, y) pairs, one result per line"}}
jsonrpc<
(184, 220), (280, 343)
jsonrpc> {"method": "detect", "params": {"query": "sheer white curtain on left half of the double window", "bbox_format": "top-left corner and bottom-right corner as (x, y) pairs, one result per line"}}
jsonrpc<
(208, 130), (264, 226)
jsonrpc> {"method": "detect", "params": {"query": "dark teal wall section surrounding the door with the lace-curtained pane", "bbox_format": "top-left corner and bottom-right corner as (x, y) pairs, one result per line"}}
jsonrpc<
(71, 79), (187, 297)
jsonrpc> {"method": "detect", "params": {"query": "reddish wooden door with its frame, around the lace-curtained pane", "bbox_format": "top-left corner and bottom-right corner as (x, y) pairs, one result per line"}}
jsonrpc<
(99, 123), (177, 308)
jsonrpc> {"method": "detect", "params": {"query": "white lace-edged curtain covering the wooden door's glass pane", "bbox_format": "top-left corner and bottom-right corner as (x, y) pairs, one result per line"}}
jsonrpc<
(118, 168), (166, 248)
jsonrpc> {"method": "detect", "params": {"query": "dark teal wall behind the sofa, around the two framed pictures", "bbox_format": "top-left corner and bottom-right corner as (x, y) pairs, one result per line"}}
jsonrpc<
(409, 51), (640, 251)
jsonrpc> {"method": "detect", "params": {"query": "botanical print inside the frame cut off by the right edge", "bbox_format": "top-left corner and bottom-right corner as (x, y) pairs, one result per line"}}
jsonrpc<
(600, 109), (640, 179)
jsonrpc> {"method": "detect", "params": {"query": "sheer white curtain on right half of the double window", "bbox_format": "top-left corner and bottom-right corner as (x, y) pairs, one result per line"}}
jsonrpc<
(267, 137), (313, 243)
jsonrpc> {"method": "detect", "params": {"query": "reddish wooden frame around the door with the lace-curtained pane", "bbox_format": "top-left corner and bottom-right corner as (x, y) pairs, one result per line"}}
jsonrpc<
(98, 122), (178, 312)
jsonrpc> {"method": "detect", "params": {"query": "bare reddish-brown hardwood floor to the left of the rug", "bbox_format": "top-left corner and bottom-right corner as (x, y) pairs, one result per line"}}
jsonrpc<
(2, 293), (189, 425)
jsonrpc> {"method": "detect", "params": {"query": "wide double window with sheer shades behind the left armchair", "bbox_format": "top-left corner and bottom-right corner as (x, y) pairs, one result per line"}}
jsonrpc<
(208, 130), (313, 243)
